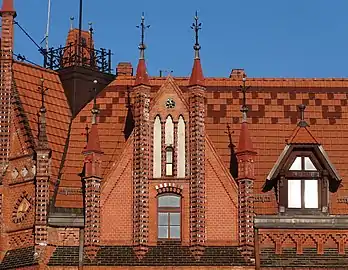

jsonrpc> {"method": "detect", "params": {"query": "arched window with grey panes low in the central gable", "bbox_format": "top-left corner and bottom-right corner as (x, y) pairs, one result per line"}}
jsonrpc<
(157, 194), (181, 240)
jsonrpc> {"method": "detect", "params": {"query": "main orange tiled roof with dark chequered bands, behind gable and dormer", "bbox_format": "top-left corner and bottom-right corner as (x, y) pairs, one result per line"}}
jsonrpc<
(53, 73), (348, 214)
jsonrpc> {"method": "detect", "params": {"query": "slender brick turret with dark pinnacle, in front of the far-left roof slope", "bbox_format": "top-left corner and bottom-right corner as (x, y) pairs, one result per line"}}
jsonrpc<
(35, 77), (51, 260)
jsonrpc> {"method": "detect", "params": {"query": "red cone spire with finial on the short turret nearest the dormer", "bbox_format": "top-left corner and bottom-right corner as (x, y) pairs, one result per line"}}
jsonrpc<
(237, 76), (256, 155)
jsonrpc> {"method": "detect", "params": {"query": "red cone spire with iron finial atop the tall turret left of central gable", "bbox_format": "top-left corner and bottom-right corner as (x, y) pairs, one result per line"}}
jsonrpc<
(134, 13), (150, 86)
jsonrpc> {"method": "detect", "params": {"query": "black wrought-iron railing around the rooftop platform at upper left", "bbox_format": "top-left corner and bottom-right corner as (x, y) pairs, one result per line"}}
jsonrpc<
(42, 42), (112, 74)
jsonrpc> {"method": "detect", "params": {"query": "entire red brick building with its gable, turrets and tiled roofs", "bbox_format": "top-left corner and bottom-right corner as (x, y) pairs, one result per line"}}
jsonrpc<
(0, 0), (348, 270)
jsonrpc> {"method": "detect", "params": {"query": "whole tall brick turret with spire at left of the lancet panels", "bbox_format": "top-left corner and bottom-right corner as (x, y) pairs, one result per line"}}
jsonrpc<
(133, 14), (151, 259)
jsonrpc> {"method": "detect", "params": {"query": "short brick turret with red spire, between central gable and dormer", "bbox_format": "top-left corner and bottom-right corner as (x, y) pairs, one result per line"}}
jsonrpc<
(236, 76), (256, 259)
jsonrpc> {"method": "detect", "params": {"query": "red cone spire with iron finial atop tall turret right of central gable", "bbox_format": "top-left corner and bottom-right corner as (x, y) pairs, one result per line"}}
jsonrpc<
(189, 11), (204, 86)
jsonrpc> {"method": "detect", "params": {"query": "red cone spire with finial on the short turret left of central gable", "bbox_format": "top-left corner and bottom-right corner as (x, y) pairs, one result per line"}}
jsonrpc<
(82, 80), (103, 154)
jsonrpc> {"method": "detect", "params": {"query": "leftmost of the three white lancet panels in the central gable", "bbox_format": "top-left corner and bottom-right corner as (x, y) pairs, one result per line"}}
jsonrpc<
(153, 116), (162, 178)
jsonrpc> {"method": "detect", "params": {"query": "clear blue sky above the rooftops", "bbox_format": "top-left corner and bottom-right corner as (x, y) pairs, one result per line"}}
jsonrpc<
(4, 0), (348, 77)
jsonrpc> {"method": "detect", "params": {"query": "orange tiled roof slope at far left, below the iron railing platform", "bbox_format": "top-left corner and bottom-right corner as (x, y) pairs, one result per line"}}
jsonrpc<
(13, 62), (71, 195)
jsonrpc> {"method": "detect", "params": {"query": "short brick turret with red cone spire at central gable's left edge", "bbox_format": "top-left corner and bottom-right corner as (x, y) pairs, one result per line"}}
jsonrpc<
(82, 80), (103, 260)
